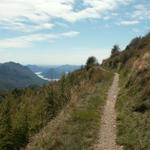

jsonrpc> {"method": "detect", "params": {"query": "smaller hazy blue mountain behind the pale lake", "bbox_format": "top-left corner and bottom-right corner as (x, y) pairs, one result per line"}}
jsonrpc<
(42, 65), (81, 79)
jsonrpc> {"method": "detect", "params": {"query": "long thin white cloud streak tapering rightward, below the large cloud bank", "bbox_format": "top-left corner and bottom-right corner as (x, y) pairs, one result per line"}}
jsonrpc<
(0, 31), (80, 49)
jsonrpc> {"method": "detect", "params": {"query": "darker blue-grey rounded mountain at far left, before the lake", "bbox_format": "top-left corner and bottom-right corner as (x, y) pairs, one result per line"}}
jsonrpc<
(0, 62), (46, 90)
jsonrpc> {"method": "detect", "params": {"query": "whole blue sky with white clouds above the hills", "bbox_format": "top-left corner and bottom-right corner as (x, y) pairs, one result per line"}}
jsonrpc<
(0, 0), (150, 65)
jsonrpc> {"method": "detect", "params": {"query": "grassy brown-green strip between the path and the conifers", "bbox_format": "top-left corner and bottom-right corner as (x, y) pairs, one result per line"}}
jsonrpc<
(26, 69), (112, 150)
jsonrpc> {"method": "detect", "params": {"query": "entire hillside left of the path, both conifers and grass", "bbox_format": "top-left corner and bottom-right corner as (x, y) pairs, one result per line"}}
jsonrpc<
(0, 66), (112, 150)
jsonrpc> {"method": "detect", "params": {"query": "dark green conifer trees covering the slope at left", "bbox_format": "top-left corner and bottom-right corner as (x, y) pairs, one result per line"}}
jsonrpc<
(0, 67), (105, 150)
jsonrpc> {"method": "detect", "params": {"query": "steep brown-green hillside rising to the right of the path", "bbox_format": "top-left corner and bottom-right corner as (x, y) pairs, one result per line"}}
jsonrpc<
(103, 34), (150, 150)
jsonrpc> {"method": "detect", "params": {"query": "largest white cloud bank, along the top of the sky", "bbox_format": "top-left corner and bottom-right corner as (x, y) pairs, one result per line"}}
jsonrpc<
(0, 0), (131, 32)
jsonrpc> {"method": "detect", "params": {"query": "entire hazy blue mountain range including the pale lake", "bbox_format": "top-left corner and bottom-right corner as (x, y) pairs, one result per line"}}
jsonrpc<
(0, 62), (80, 91)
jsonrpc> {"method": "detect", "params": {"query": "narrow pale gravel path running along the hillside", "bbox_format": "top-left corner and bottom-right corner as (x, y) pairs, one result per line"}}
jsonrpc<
(95, 74), (123, 150)
